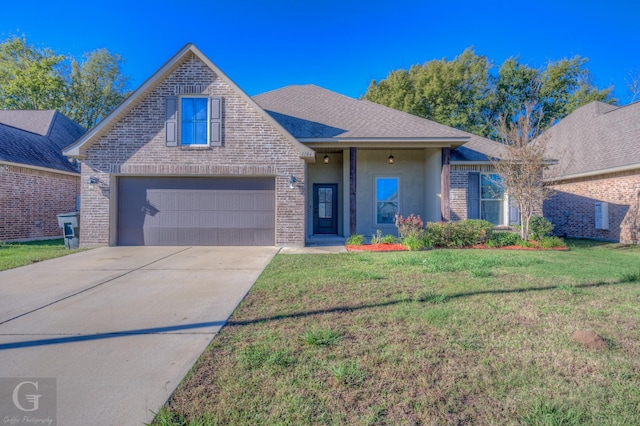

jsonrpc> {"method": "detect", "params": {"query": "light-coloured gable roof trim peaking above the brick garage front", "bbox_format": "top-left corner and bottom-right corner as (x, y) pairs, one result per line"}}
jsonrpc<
(64, 43), (315, 161)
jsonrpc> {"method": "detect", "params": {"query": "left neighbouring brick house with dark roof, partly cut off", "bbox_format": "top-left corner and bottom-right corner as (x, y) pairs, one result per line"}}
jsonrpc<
(0, 110), (85, 241)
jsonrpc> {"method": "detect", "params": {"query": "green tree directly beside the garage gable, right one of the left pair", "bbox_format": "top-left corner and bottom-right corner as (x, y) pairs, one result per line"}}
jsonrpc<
(64, 49), (128, 129)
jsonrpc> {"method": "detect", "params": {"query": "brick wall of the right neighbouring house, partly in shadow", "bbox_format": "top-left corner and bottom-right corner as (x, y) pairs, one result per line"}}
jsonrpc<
(544, 170), (640, 244)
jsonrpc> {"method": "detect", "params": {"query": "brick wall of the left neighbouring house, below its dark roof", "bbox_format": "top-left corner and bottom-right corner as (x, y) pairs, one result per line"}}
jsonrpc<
(0, 165), (80, 241)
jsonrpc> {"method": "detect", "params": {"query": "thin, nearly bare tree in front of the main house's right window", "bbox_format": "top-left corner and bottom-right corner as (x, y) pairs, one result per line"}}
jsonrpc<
(493, 101), (553, 240)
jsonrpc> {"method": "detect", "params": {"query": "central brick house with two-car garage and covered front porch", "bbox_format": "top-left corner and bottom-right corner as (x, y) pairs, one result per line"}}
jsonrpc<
(64, 44), (508, 246)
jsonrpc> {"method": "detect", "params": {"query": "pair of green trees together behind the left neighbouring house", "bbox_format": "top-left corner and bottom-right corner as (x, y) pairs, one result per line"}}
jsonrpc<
(0, 37), (128, 128)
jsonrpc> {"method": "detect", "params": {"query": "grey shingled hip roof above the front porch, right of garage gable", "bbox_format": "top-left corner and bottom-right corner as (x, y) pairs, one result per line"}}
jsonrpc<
(253, 85), (469, 145)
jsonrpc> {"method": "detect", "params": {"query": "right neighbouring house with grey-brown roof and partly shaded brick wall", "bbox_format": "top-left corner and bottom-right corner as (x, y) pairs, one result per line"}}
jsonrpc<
(543, 102), (640, 244)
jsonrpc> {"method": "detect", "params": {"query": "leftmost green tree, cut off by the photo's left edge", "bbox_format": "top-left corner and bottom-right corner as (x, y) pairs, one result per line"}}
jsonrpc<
(0, 37), (65, 109)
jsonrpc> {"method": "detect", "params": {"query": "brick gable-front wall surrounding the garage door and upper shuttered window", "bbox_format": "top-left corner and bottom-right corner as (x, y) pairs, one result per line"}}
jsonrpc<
(80, 52), (305, 246)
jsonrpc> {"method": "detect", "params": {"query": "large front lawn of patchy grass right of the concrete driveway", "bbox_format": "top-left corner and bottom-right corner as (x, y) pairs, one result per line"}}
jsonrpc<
(155, 241), (640, 425)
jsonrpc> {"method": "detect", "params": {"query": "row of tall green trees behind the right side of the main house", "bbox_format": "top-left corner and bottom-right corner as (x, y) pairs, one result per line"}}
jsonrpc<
(364, 48), (616, 140)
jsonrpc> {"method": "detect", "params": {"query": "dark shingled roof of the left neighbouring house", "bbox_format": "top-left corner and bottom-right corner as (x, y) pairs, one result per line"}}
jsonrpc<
(0, 110), (85, 173)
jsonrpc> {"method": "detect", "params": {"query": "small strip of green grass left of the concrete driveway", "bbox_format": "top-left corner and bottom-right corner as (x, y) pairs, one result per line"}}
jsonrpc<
(0, 238), (80, 271)
